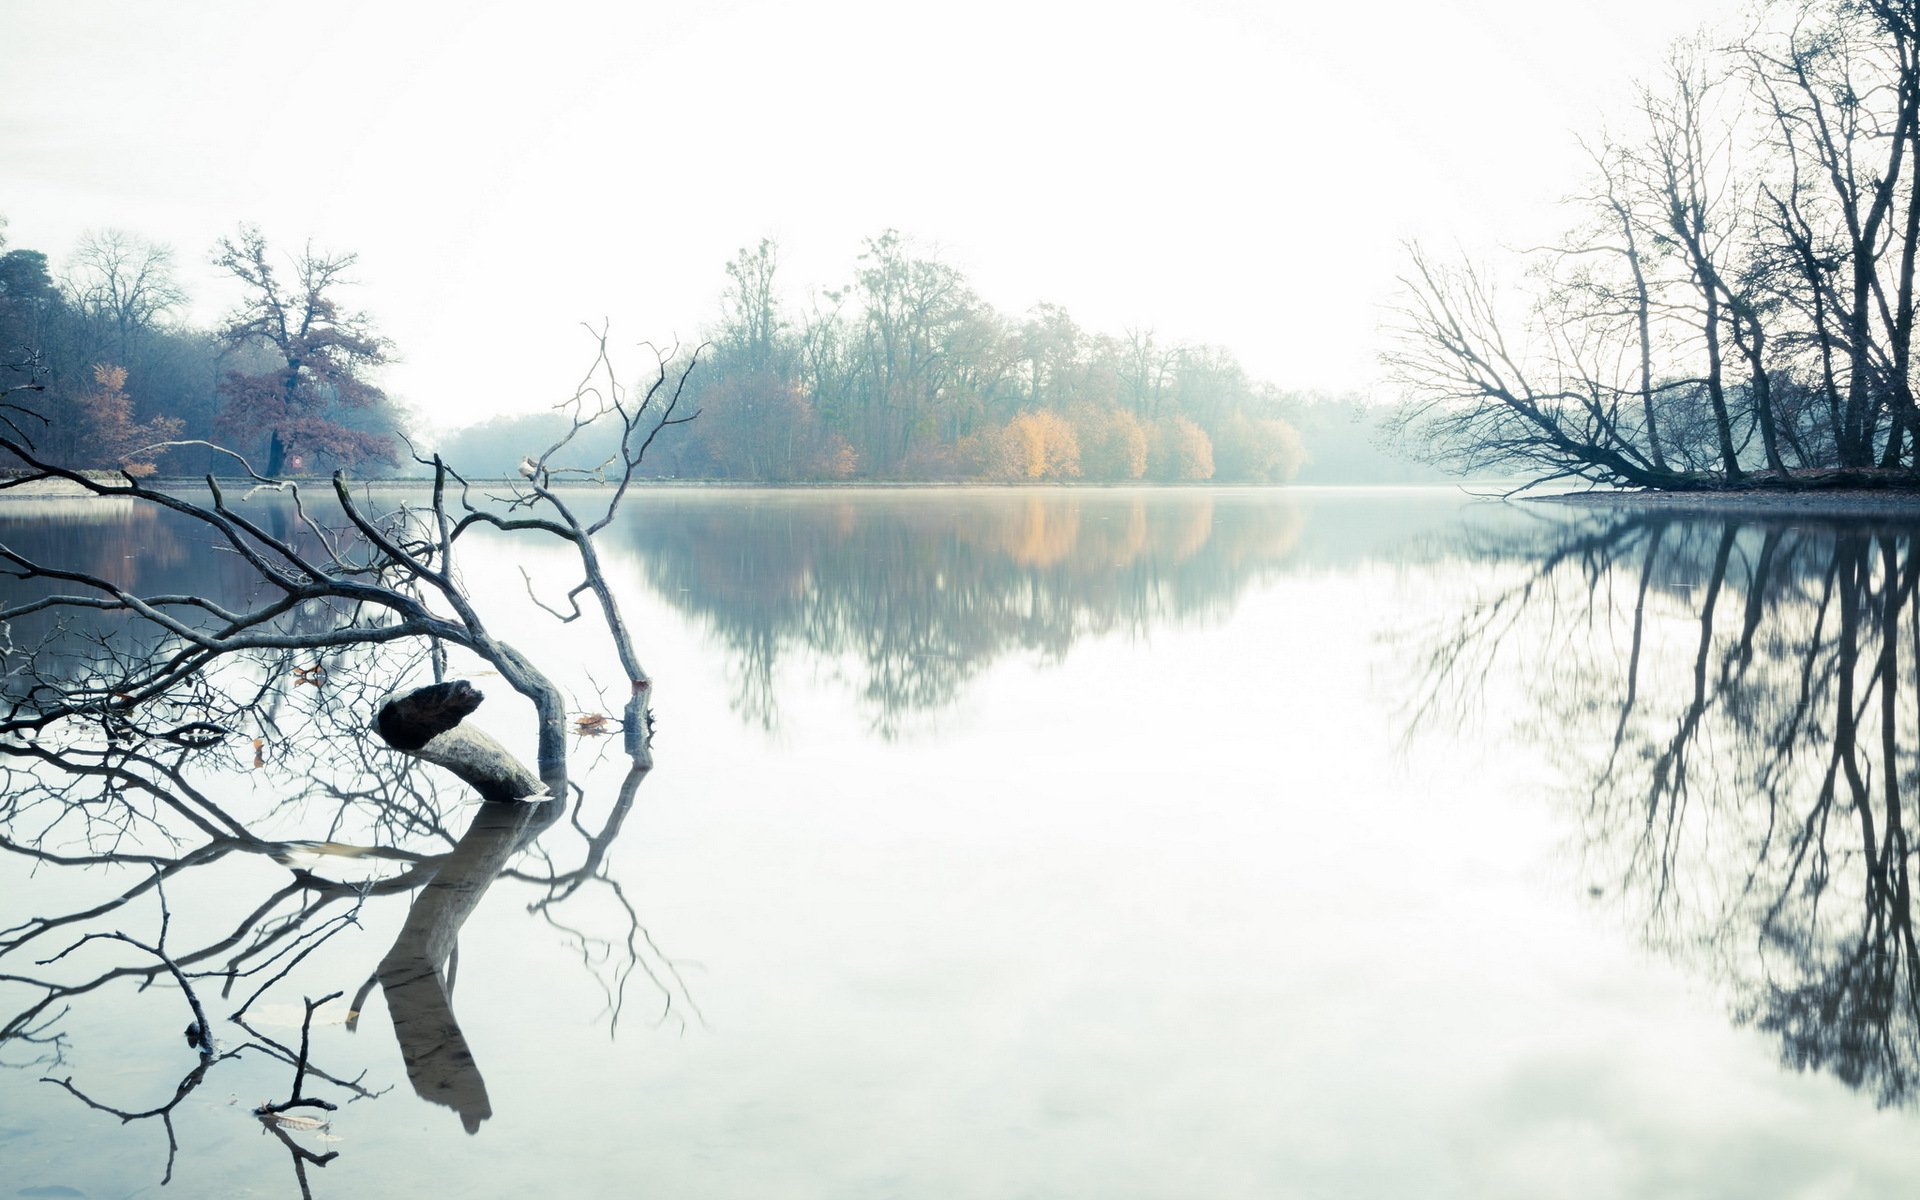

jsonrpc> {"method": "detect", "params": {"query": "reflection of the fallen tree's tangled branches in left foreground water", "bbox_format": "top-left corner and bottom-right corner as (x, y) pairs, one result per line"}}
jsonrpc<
(0, 505), (687, 1192)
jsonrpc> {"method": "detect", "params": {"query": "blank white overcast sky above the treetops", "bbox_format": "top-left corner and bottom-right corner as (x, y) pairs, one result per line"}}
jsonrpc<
(0, 0), (1736, 424)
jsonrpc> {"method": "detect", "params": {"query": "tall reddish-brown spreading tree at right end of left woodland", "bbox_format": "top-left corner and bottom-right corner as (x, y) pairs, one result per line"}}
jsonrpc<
(215, 227), (396, 476)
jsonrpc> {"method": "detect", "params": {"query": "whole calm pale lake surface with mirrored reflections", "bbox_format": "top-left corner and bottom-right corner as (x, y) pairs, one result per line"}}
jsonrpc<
(0, 481), (1920, 1198)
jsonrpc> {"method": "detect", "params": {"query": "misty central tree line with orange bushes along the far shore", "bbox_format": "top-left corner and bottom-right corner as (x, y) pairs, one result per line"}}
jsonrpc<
(447, 230), (1308, 484)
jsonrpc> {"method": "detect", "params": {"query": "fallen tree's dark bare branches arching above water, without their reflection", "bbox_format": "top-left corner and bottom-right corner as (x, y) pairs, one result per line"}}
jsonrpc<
(0, 340), (697, 795)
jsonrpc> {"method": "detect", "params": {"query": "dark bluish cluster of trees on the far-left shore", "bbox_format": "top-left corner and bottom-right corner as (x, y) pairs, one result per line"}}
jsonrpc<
(0, 221), (407, 476)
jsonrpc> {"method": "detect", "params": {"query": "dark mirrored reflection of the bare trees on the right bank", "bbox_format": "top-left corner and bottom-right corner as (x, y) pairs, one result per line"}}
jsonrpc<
(1419, 511), (1920, 1106)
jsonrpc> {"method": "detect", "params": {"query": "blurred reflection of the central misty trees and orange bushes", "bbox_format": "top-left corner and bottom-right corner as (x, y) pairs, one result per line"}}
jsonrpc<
(616, 490), (1302, 737)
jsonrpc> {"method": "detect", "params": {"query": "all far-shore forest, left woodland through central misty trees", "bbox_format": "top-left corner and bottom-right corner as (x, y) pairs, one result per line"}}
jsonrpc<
(0, 215), (1409, 484)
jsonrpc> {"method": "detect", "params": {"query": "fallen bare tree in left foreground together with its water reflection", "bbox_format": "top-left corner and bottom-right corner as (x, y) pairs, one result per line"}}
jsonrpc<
(0, 332), (706, 1183)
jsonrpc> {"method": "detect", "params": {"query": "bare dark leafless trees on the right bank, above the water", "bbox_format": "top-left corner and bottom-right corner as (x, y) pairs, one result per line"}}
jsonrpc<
(1390, 0), (1920, 488)
